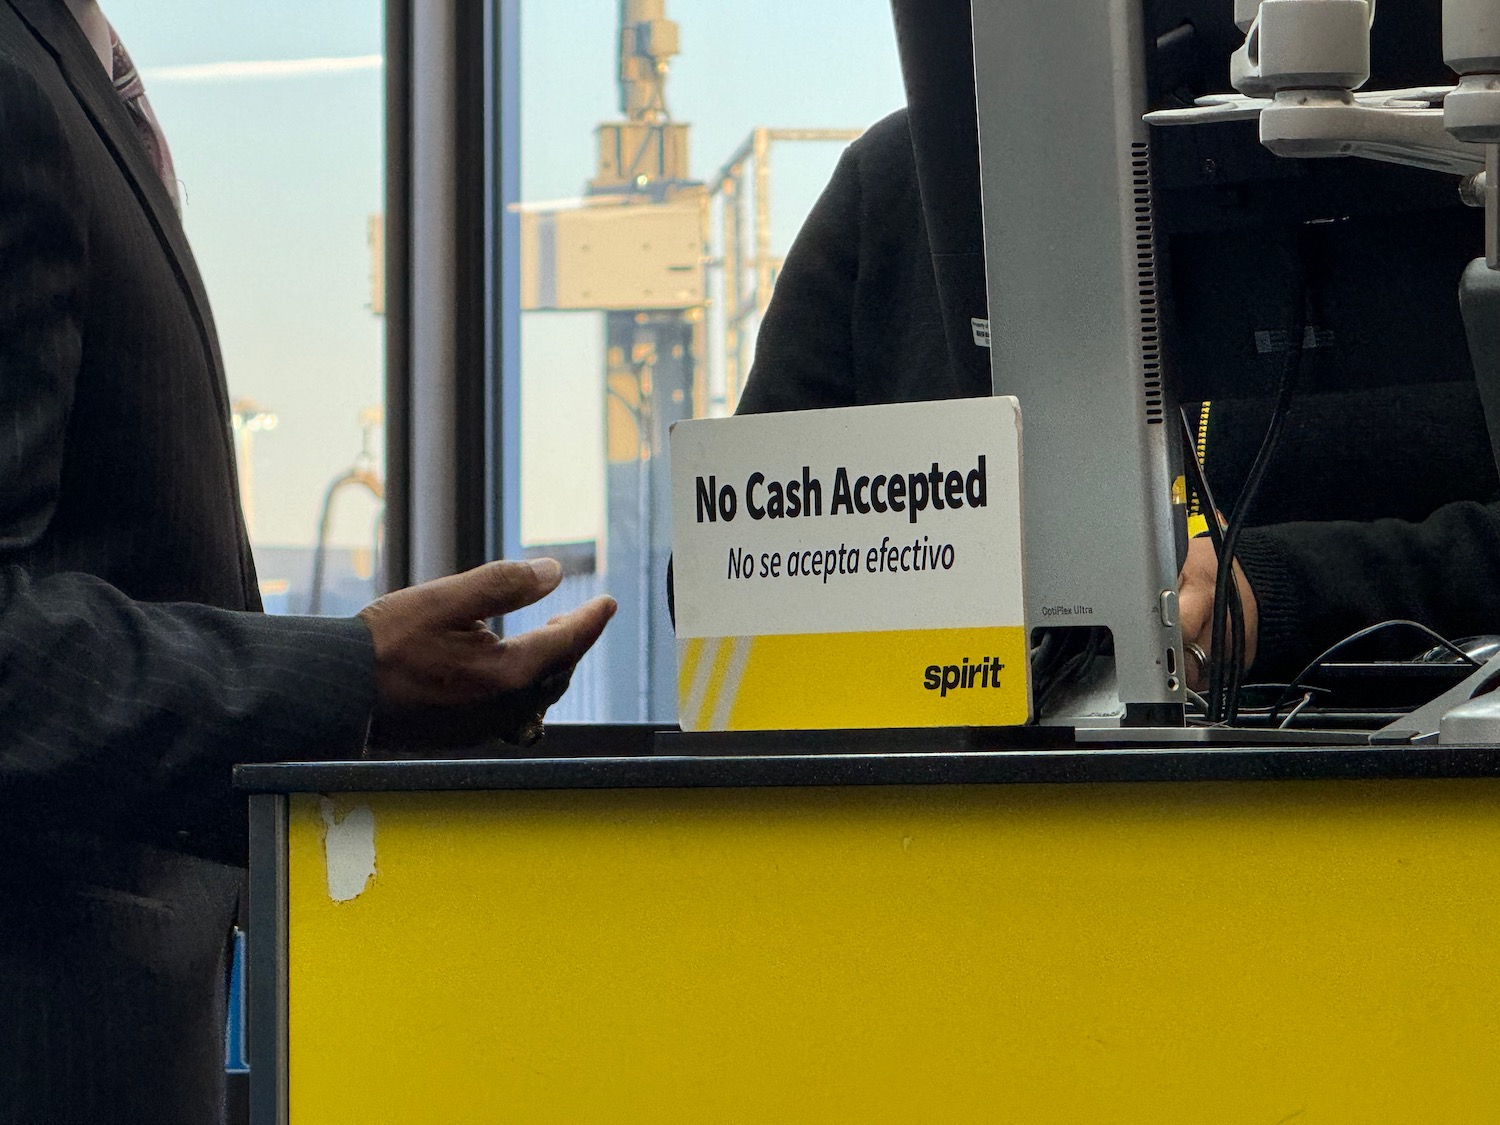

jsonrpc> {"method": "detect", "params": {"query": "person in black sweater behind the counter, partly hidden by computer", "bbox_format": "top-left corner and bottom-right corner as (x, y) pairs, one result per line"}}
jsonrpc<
(737, 105), (1500, 681)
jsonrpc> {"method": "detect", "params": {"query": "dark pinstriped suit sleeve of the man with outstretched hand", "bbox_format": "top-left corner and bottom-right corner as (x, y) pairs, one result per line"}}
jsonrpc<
(0, 54), (374, 821)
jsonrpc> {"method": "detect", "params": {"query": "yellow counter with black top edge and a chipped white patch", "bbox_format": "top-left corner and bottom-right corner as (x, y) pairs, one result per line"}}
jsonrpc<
(240, 749), (1500, 1125)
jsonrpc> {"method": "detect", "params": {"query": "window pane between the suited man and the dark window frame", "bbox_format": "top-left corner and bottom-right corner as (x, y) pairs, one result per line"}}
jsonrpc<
(102, 0), (384, 614)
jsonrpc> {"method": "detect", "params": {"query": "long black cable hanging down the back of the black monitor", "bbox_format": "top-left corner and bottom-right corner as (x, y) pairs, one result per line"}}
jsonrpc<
(1208, 234), (1310, 726)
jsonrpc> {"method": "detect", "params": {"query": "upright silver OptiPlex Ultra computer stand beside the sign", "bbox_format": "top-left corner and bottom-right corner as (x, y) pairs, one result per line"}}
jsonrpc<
(974, 0), (1184, 728)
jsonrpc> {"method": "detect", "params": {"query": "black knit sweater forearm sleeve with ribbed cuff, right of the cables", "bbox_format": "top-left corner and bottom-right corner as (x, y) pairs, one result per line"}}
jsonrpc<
(1236, 501), (1500, 681)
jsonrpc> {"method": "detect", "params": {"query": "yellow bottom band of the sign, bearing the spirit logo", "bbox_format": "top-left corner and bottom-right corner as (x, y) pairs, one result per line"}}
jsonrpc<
(678, 626), (1029, 731)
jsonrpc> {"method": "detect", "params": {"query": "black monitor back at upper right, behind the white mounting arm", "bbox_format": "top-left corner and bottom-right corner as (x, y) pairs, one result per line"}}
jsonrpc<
(1143, 0), (1484, 401)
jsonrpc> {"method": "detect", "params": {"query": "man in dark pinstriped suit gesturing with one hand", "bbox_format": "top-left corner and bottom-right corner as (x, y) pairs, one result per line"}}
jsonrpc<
(0, 0), (614, 1125)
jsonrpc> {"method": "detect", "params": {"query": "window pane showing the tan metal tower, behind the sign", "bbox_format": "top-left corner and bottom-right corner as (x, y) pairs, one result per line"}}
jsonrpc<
(507, 0), (905, 722)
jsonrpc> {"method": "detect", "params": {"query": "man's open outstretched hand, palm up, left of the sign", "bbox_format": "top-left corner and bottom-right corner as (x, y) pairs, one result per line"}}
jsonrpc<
(359, 558), (617, 750)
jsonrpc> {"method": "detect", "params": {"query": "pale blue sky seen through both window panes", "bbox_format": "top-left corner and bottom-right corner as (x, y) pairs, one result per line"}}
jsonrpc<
(102, 0), (903, 546)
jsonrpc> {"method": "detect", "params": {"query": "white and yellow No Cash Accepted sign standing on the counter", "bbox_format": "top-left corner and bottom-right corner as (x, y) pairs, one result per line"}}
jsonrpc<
(672, 398), (1029, 731)
